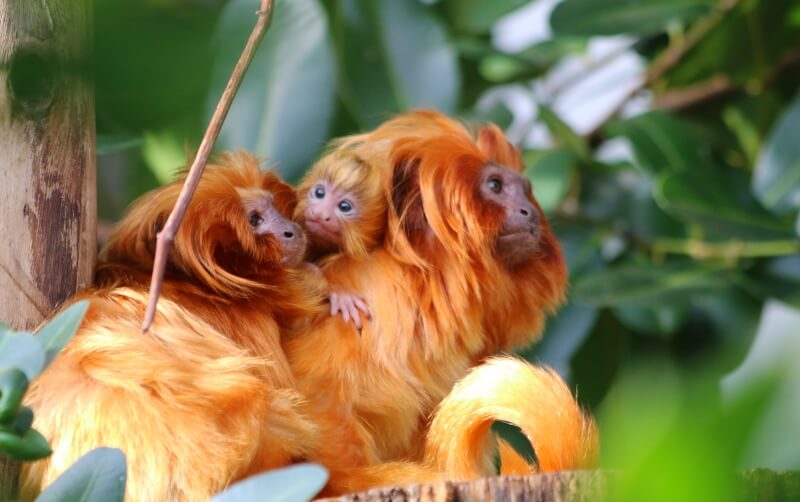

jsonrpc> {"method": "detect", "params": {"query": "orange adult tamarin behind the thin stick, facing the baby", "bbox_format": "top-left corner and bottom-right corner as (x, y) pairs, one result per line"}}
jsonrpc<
(21, 154), (320, 501)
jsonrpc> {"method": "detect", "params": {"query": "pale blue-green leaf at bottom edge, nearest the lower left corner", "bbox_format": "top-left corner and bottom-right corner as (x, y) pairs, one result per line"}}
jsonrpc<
(36, 448), (128, 502)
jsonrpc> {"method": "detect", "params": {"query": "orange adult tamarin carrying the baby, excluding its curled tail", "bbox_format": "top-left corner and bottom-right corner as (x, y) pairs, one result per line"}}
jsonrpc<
(284, 115), (594, 493)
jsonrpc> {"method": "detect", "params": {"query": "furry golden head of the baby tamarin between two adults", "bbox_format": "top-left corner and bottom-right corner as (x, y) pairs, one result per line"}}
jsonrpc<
(295, 149), (387, 258)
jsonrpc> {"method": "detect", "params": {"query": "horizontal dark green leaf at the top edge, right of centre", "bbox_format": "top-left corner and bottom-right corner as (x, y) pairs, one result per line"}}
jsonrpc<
(550, 0), (714, 36)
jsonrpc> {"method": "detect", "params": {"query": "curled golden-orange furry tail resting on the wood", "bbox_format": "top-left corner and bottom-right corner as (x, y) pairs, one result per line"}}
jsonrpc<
(425, 357), (598, 479)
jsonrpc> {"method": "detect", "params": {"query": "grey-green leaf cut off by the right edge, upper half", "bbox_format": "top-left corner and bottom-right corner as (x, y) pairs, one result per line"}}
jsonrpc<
(753, 93), (800, 214)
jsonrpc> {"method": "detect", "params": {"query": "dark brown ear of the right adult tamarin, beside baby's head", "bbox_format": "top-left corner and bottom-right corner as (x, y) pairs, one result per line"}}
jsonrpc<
(389, 156), (428, 237)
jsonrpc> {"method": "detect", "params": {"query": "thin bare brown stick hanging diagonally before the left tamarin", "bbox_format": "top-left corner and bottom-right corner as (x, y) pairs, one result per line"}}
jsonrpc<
(142, 0), (273, 331)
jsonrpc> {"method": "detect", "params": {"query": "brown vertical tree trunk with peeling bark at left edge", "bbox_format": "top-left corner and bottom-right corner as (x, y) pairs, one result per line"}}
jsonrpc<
(0, 0), (97, 500)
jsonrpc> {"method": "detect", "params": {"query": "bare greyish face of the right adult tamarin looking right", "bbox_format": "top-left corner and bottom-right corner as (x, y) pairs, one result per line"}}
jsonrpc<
(480, 164), (541, 267)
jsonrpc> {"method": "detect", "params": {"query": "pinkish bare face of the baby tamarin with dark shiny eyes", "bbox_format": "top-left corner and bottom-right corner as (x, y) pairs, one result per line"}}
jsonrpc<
(303, 181), (359, 247)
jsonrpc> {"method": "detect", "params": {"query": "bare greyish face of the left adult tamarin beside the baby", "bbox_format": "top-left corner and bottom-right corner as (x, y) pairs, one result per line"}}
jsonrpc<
(245, 196), (306, 267)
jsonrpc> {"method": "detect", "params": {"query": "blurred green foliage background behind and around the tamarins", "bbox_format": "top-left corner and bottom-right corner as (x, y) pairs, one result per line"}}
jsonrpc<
(95, 0), (800, 500)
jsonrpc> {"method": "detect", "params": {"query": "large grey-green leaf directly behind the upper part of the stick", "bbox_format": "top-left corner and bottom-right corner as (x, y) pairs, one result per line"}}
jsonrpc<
(206, 0), (335, 178)
